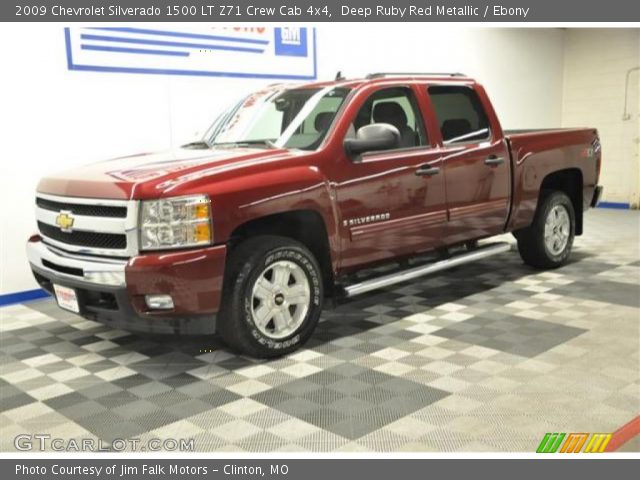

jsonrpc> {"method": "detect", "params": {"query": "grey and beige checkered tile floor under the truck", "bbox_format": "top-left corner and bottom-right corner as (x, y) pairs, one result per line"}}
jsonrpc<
(0, 210), (640, 452)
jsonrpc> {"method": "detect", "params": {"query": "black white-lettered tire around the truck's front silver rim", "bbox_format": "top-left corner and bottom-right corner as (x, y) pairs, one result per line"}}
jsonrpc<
(217, 235), (324, 358)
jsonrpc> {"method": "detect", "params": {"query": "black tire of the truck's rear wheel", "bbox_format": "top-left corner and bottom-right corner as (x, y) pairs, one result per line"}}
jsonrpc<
(515, 191), (576, 269)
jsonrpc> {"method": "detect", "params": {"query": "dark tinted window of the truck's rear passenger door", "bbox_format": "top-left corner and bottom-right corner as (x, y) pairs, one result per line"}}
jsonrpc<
(429, 86), (490, 144)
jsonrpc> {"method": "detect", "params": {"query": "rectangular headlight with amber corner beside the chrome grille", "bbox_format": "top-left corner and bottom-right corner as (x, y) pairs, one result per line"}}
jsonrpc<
(140, 195), (213, 250)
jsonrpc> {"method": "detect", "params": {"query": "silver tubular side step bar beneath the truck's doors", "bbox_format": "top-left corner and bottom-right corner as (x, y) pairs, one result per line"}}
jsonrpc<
(344, 242), (511, 297)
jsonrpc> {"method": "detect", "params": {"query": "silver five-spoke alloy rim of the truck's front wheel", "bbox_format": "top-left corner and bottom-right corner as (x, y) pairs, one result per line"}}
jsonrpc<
(251, 260), (311, 340)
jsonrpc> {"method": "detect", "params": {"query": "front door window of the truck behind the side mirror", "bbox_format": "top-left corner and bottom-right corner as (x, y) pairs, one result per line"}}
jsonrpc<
(351, 87), (427, 148)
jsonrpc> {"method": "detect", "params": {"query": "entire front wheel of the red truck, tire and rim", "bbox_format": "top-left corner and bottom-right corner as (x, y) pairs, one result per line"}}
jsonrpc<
(218, 235), (323, 358)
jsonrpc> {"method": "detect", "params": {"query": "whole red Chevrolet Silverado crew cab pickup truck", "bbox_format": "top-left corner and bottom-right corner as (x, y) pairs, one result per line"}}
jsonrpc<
(27, 74), (601, 357)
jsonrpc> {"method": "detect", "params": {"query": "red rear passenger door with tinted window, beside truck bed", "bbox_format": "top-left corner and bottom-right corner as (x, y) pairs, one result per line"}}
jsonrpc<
(428, 85), (510, 244)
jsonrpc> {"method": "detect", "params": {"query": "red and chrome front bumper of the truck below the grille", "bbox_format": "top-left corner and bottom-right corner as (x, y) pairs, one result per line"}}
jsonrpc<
(27, 235), (226, 334)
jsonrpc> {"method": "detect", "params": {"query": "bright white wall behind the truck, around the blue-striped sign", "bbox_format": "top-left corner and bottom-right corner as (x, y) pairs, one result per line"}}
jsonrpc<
(0, 24), (564, 294)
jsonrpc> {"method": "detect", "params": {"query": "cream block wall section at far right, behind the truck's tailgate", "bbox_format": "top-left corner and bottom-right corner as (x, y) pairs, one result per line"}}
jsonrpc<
(562, 29), (640, 208)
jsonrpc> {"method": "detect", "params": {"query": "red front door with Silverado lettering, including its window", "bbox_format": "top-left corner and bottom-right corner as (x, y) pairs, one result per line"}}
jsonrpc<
(336, 86), (447, 269)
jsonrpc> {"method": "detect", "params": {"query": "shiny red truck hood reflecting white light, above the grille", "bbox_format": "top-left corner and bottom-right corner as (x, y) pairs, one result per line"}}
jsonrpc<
(38, 148), (301, 199)
